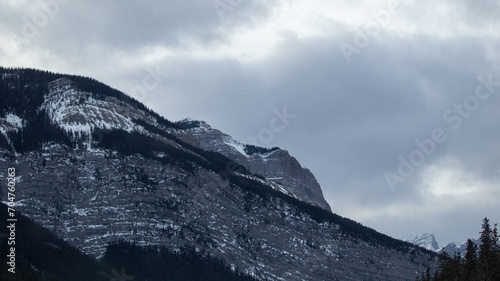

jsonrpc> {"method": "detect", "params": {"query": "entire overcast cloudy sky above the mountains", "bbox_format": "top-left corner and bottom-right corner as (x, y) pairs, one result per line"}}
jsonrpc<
(0, 0), (500, 245)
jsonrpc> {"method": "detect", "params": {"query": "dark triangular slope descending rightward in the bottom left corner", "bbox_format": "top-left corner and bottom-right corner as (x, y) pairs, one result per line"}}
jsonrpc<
(0, 201), (112, 281)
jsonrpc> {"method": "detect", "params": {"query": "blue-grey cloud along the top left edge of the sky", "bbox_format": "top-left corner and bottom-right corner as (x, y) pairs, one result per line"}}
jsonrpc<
(0, 0), (273, 62)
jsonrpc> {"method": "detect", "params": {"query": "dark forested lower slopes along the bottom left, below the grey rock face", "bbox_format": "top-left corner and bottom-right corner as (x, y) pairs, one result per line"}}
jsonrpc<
(0, 203), (262, 281)
